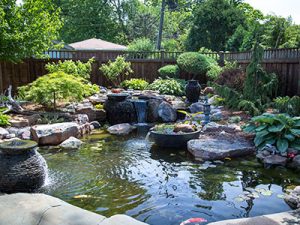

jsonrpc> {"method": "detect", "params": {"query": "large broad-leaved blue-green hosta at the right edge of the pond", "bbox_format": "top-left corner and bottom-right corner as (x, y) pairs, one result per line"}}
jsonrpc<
(244, 113), (300, 153)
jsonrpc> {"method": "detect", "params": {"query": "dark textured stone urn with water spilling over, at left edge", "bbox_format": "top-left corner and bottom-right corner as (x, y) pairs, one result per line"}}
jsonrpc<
(0, 140), (48, 193)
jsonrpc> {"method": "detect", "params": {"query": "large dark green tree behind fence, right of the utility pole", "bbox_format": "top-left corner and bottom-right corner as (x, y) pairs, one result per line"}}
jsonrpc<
(186, 0), (245, 51)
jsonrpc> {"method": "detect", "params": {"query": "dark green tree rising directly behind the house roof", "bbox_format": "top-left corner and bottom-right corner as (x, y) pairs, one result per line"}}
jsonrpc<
(58, 0), (123, 43)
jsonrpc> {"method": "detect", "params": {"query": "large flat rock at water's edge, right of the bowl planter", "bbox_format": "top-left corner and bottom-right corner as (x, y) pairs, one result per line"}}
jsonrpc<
(188, 137), (255, 160)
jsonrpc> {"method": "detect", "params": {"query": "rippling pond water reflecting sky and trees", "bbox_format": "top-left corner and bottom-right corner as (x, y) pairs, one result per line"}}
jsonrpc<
(40, 128), (300, 225)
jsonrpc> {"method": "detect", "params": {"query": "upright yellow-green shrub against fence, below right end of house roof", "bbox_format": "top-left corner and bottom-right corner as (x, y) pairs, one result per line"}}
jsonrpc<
(99, 56), (133, 86)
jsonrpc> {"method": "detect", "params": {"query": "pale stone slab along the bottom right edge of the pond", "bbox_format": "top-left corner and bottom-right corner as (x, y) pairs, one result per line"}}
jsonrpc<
(208, 210), (300, 225)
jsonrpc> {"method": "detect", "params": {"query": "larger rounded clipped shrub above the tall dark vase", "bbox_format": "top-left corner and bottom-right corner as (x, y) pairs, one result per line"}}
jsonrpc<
(177, 52), (210, 78)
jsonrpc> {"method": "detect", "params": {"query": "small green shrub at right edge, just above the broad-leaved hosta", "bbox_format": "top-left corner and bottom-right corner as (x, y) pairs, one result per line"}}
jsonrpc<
(274, 96), (300, 116)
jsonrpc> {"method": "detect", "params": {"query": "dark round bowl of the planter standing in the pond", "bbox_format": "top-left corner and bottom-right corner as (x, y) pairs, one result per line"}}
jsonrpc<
(149, 130), (201, 148)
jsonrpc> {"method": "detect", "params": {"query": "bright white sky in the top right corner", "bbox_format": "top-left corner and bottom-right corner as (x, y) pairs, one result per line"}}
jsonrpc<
(245, 0), (300, 24)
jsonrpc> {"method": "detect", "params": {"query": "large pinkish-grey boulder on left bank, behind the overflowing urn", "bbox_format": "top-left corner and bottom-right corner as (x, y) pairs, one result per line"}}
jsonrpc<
(31, 122), (79, 145)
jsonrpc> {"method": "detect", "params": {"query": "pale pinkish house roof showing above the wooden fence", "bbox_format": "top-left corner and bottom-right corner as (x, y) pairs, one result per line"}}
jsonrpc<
(69, 38), (127, 50)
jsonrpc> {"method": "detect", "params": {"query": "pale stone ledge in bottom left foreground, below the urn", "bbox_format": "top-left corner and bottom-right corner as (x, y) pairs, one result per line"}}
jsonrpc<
(0, 193), (147, 225)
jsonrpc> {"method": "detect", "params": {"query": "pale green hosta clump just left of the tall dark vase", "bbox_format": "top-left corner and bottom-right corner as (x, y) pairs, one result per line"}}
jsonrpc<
(148, 78), (185, 96)
